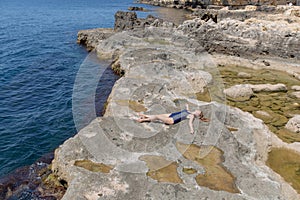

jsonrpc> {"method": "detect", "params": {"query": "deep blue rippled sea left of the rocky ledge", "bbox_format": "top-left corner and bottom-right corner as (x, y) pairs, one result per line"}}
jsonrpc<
(0, 0), (158, 176)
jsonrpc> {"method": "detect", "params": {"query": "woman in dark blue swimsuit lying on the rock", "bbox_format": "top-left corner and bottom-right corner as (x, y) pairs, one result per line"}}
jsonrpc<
(137, 104), (209, 134)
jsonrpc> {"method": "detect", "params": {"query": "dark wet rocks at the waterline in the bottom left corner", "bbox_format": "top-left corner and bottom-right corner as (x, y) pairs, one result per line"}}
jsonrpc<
(0, 153), (66, 200)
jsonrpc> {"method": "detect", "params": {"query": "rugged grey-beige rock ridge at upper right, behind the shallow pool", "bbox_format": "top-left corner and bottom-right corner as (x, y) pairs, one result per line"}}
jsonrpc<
(178, 8), (300, 59)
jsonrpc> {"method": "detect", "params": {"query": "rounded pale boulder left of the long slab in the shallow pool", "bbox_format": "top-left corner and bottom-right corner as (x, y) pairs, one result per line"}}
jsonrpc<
(224, 84), (254, 101)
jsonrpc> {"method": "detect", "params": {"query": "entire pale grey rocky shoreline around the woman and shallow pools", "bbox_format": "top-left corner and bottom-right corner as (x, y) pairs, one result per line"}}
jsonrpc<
(52, 5), (300, 200)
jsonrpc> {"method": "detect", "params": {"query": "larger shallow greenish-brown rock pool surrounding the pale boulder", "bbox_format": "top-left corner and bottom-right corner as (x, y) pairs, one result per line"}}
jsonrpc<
(197, 66), (300, 143)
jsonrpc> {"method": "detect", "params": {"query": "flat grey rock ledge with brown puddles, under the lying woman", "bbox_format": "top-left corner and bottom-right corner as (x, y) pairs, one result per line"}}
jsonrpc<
(52, 12), (300, 200)
